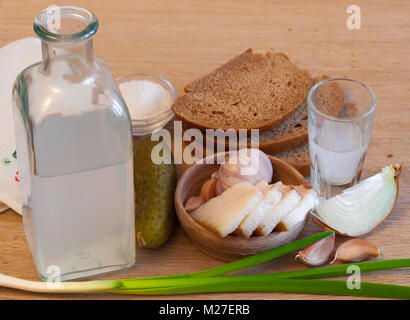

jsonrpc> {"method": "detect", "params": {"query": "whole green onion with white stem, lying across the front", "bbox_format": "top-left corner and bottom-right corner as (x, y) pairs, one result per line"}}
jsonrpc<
(0, 231), (410, 299)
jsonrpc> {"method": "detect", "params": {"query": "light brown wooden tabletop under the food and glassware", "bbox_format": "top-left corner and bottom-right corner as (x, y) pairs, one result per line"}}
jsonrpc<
(0, 0), (410, 299)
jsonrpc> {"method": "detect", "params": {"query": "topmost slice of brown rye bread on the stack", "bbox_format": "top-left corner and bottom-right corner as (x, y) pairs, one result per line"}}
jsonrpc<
(172, 49), (309, 132)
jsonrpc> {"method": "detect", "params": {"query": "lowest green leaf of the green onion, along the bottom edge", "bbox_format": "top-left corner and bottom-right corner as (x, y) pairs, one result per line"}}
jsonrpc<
(114, 275), (410, 299)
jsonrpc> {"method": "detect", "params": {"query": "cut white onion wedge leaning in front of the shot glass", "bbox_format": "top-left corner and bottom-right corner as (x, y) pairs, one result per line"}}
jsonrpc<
(314, 165), (401, 237)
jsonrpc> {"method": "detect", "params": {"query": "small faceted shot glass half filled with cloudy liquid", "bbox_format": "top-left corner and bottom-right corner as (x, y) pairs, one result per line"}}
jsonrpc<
(307, 78), (377, 199)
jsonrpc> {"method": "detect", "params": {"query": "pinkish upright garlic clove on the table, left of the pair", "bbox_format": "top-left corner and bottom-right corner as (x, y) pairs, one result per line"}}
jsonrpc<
(296, 233), (335, 266)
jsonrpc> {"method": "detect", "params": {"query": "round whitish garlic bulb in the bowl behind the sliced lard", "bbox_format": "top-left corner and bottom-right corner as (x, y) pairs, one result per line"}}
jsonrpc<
(213, 148), (273, 195)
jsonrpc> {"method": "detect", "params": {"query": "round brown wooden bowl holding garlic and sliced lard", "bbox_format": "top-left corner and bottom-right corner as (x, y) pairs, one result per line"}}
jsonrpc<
(175, 156), (305, 261)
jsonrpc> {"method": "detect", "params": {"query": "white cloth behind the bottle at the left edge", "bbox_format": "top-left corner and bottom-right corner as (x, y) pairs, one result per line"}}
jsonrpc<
(0, 38), (41, 214)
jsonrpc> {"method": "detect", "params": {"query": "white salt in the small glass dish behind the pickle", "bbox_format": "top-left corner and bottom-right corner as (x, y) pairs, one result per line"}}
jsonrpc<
(119, 80), (172, 120)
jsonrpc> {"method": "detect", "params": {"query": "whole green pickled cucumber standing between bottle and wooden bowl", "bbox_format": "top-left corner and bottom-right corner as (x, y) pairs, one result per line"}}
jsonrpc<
(134, 135), (177, 248)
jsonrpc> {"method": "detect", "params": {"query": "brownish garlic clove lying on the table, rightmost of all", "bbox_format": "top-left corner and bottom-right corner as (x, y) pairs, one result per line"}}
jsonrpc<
(335, 239), (380, 262)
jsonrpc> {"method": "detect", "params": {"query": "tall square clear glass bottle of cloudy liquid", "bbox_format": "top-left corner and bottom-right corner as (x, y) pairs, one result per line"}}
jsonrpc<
(13, 6), (135, 280)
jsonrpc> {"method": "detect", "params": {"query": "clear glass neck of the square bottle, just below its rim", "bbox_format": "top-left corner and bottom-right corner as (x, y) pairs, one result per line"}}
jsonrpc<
(41, 38), (94, 68)
